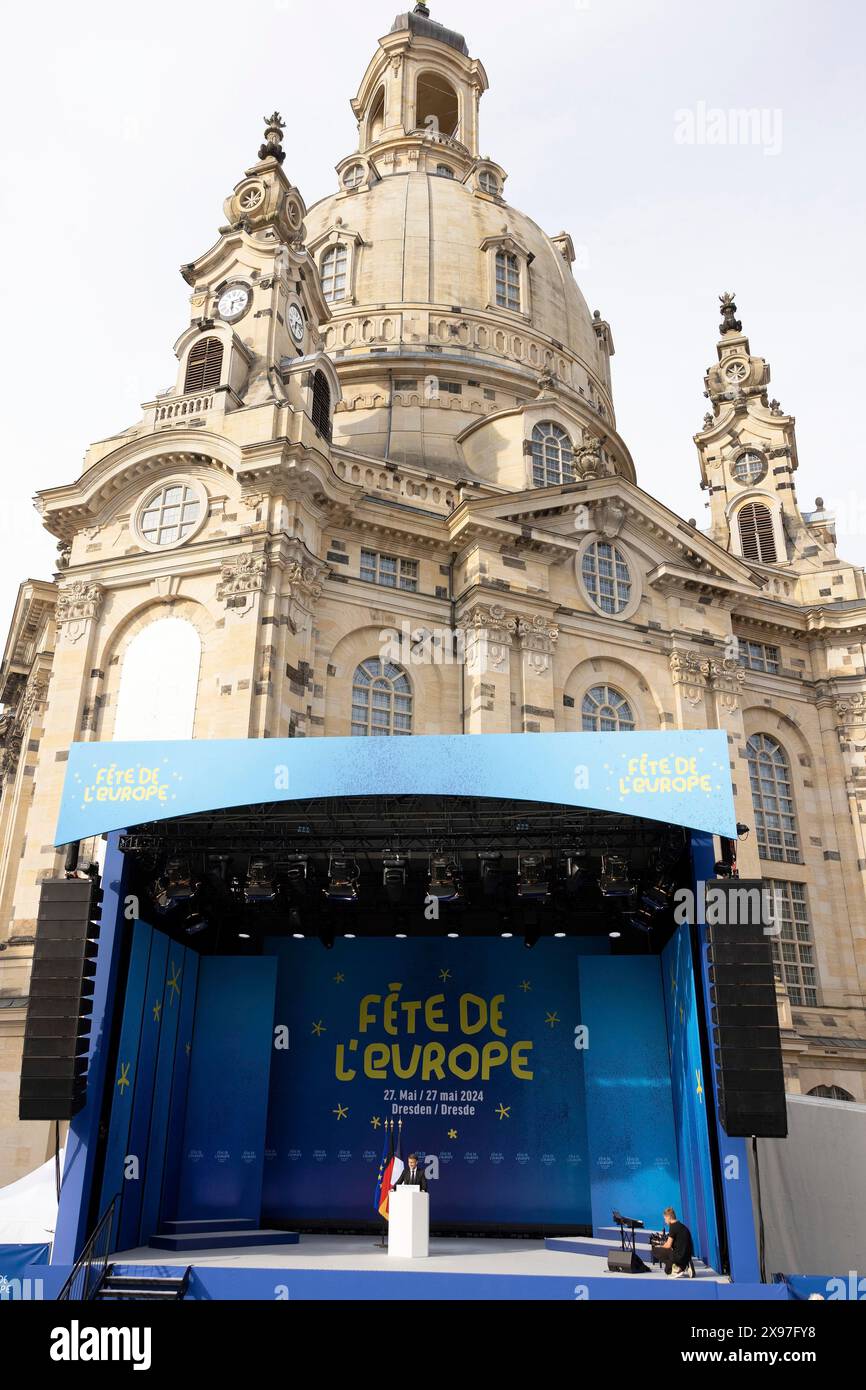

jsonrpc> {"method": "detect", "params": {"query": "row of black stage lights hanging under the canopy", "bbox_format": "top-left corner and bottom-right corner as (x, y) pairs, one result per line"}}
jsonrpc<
(143, 847), (681, 945)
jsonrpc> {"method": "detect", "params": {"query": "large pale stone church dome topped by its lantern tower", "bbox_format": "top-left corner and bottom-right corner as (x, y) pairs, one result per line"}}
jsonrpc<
(307, 4), (634, 488)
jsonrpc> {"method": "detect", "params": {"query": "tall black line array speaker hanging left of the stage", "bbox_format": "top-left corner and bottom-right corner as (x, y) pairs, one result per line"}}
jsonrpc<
(18, 878), (103, 1120)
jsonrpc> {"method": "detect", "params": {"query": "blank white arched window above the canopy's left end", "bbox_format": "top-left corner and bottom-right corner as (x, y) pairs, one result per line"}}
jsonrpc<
(111, 617), (202, 742)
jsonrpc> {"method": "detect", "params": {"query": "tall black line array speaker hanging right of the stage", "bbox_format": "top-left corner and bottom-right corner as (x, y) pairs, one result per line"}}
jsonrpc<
(706, 878), (788, 1138)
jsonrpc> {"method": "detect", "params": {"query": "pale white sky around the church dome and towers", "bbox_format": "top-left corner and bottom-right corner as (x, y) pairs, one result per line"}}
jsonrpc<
(0, 0), (866, 635)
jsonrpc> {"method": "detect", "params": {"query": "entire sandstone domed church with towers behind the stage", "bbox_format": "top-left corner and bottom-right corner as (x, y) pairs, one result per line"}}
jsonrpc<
(0, 4), (866, 1184)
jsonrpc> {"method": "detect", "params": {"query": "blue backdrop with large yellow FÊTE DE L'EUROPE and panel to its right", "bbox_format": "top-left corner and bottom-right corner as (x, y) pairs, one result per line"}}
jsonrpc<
(263, 938), (678, 1226)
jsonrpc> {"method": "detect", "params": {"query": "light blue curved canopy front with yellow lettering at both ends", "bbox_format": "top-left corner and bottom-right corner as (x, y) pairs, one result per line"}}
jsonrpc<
(56, 730), (737, 845)
